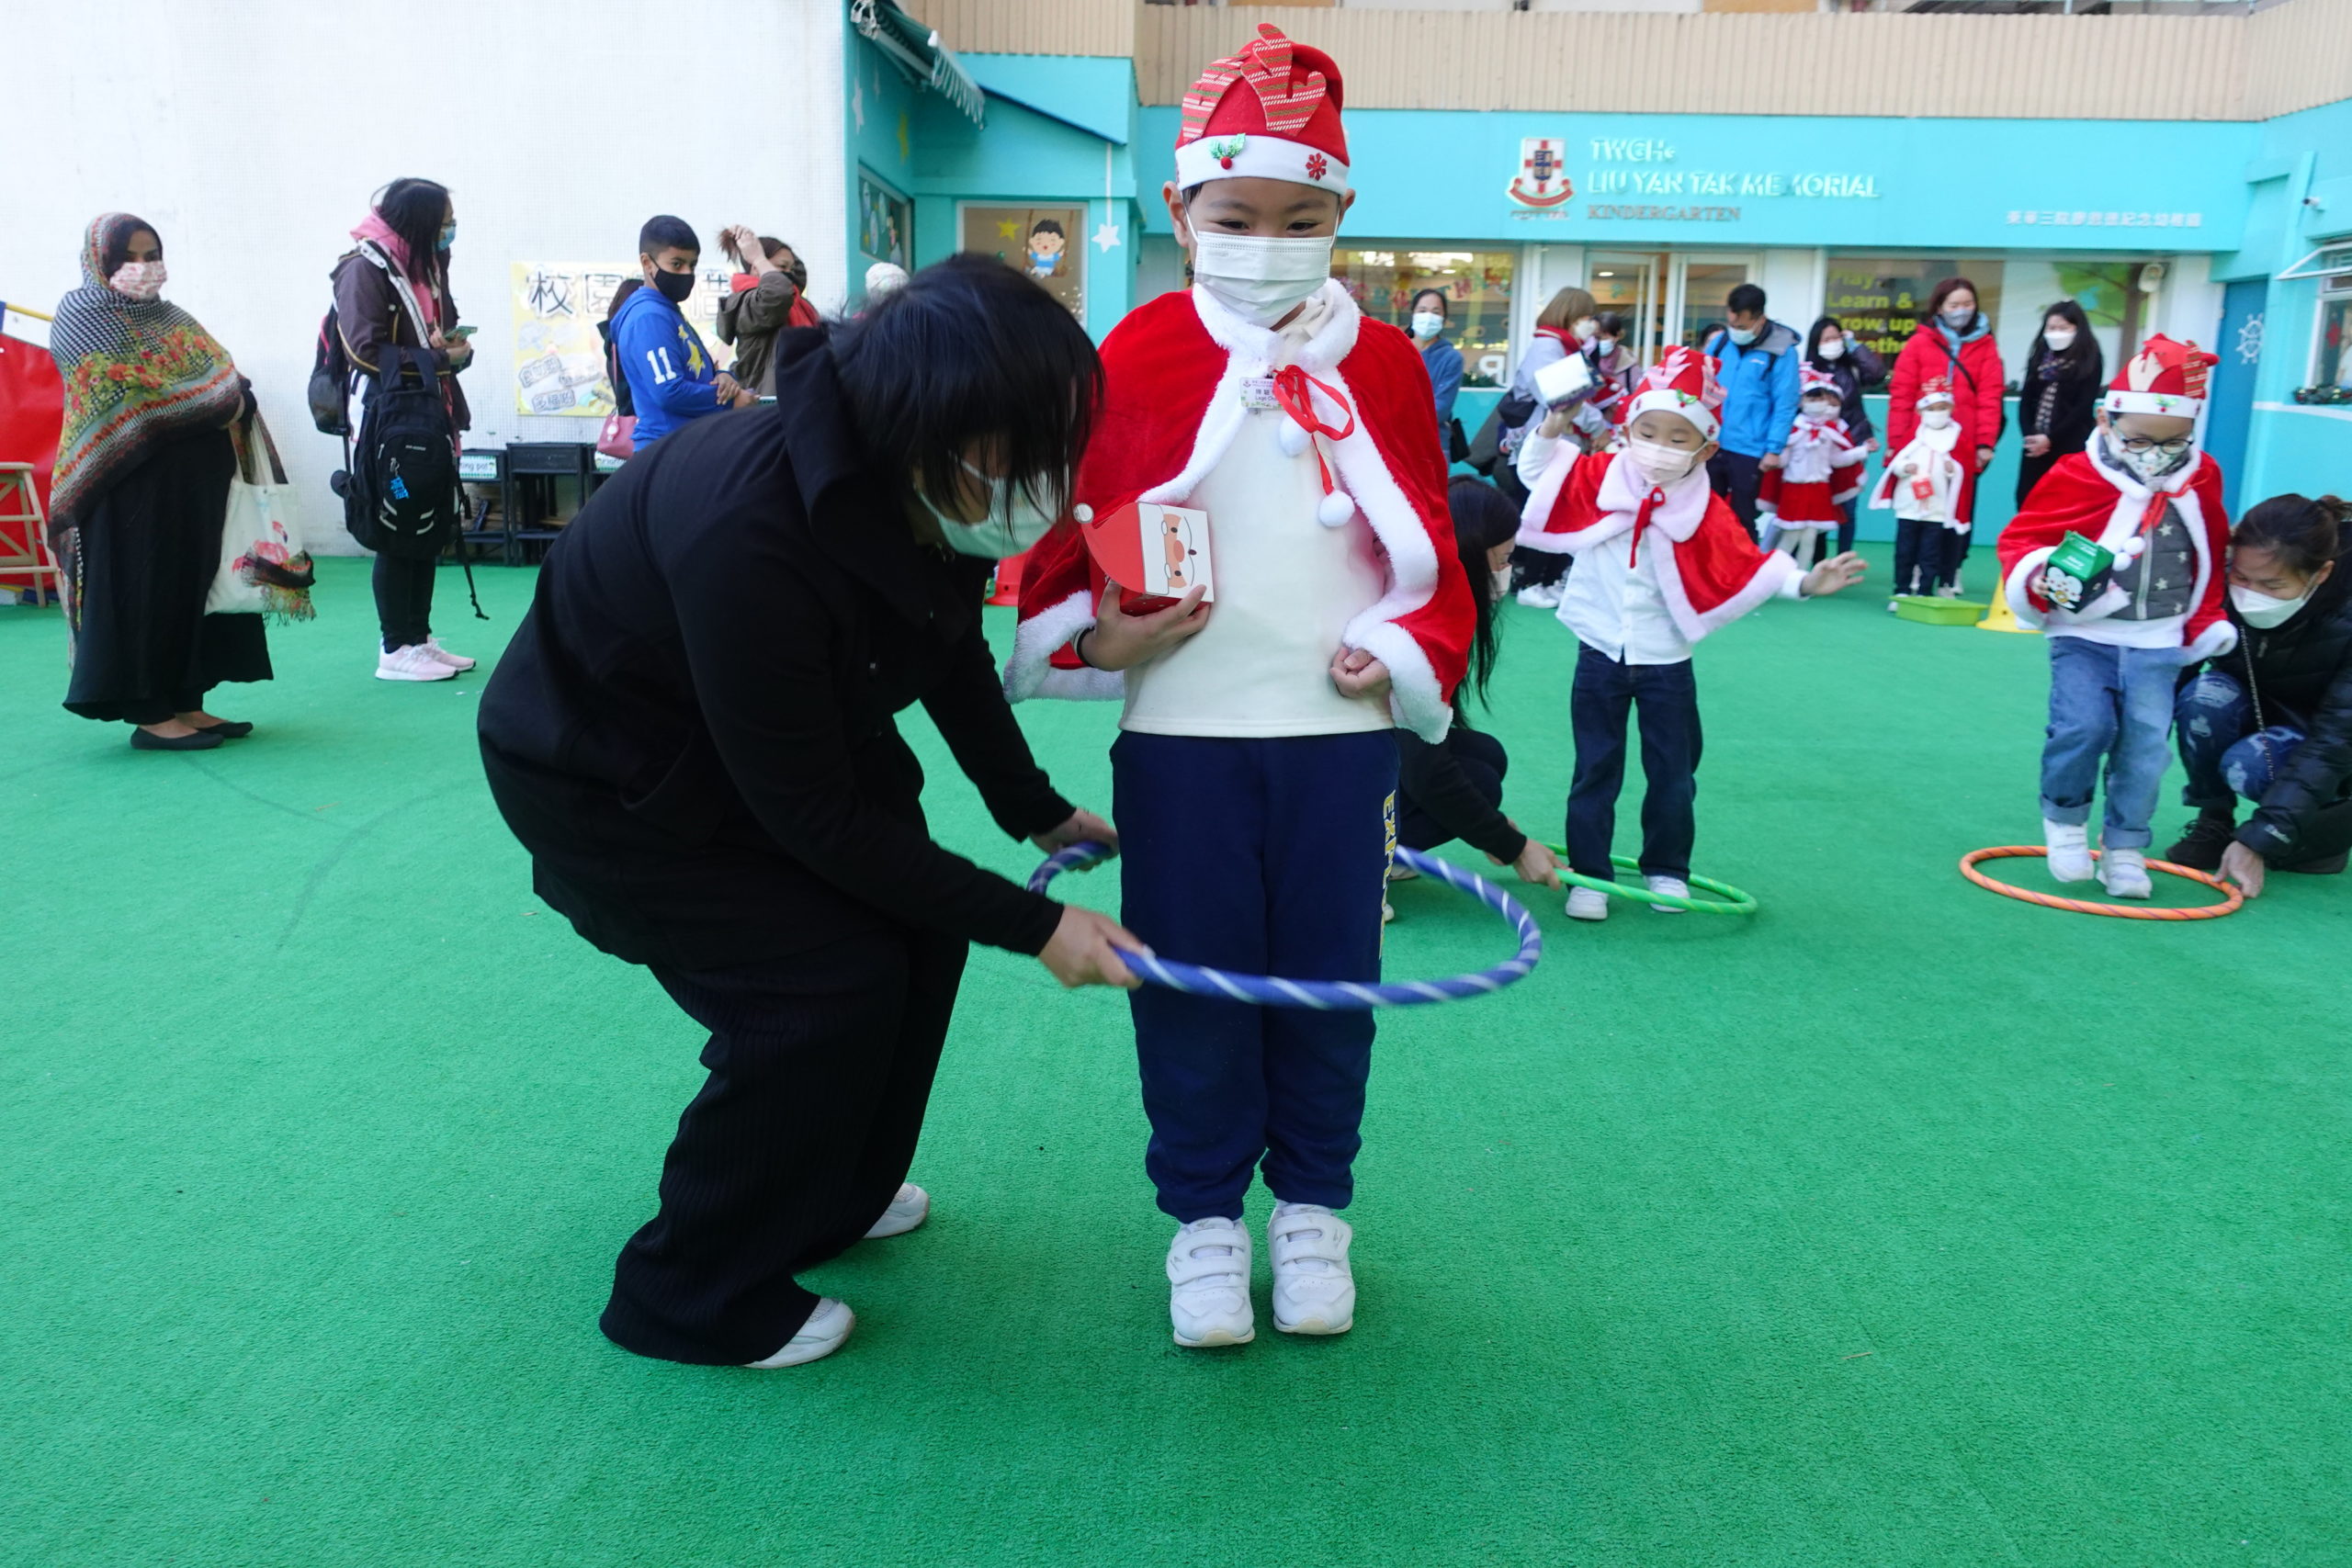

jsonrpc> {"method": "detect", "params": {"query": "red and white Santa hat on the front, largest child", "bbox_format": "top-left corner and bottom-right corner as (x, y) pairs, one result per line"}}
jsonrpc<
(1176, 21), (1348, 193)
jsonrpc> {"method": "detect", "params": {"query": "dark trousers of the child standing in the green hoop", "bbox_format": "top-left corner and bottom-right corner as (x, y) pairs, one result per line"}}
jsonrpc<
(1569, 647), (1701, 879)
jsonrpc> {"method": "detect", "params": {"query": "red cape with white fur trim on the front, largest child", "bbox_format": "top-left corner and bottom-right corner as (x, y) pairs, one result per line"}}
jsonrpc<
(1004, 282), (1477, 740)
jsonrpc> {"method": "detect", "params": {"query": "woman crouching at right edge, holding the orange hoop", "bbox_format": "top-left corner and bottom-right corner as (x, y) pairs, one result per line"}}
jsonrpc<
(2166, 496), (2352, 898)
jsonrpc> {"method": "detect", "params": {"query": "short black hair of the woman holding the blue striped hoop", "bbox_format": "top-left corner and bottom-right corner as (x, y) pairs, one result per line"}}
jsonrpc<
(831, 254), (1103, 517)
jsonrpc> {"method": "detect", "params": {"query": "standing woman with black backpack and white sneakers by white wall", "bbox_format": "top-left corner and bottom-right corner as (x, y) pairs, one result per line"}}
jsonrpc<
(334, 179), (475, 682)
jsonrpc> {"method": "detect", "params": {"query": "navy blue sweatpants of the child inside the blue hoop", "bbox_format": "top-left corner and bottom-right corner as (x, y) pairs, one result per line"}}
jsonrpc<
(1110, 728), (1397, 1224)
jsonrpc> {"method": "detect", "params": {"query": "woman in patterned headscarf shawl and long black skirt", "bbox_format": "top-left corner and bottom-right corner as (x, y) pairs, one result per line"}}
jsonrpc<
(50, 211), (270, 752)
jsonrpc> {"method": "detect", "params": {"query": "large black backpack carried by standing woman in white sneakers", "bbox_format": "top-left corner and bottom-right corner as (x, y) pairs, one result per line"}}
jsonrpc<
(345, 348), (463, 558)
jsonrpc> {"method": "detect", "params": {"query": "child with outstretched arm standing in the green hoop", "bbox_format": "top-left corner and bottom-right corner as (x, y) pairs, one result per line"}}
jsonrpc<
(1520, 348), (1863, 919)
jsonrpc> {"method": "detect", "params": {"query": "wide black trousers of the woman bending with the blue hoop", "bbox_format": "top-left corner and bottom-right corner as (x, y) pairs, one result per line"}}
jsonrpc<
(602, 931), (967, 1366)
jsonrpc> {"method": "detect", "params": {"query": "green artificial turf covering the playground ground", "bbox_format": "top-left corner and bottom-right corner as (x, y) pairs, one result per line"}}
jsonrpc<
(0, 552), (2352, 1568)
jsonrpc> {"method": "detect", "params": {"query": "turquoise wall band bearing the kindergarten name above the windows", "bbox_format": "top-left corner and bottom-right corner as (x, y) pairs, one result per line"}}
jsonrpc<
(1136, 106), (2260, 252)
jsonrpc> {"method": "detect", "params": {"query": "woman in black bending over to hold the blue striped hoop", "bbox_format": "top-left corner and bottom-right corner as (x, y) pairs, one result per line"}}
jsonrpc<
(482, 259), (1141, 1368)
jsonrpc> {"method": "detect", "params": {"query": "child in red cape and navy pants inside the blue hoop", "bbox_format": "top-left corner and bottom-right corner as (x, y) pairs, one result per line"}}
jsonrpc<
(1004, 26), (1477, 1347)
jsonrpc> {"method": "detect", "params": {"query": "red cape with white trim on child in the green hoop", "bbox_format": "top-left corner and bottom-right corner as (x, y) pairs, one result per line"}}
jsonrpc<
(1520, 449), (1802, 642)
